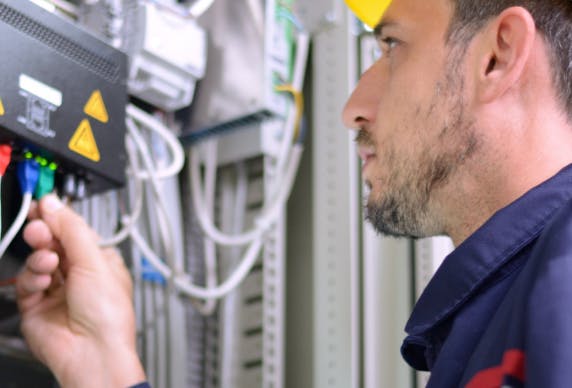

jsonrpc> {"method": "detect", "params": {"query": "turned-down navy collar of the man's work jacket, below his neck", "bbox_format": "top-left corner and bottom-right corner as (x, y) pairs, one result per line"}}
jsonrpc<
(405, 165), (572, 335)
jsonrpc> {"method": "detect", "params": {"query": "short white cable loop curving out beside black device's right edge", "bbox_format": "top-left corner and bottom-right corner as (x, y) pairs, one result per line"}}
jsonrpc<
(127, 104), (185, 179)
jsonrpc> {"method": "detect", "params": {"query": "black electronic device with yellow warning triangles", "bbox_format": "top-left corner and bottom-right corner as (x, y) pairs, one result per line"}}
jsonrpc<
(0, 0), (127, 193)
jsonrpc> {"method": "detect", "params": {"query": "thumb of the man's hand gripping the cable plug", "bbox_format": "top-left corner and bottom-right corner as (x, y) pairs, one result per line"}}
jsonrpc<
(39, 194), (100, 268)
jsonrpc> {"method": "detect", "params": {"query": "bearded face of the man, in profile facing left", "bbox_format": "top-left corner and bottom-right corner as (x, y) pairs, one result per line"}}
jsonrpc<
(344, 0), (480, 237)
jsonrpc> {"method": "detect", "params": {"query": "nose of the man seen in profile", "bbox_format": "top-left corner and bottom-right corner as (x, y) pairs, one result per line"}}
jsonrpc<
(342, 65), (381, 129)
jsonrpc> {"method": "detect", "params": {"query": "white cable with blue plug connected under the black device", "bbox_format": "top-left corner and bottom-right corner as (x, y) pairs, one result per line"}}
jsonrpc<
(0, 159), (40, 258)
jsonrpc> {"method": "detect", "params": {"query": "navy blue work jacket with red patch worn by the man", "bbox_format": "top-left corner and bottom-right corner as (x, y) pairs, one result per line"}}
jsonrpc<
(401, 166), (572, 388)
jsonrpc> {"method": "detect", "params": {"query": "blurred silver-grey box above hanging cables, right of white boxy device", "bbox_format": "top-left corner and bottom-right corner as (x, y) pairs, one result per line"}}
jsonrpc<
(184, 0), (295, 141)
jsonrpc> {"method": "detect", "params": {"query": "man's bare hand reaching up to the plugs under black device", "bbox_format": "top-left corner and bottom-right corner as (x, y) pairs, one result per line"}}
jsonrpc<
(17, 195), (145, 388)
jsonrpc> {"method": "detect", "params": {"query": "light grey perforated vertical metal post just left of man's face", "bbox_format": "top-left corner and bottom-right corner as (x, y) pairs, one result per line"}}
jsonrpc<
(312, 2), (361, 388)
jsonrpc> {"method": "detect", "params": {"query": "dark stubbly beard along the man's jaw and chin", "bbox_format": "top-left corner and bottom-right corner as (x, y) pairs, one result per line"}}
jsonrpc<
(364, 60), (480, 238)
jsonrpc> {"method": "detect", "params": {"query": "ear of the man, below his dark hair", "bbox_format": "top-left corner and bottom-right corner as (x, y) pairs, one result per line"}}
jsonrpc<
(477, 7), (536, 103)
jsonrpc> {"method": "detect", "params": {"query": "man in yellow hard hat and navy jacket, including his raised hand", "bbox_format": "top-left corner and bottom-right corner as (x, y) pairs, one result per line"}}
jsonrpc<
(13, 0), (572, 387)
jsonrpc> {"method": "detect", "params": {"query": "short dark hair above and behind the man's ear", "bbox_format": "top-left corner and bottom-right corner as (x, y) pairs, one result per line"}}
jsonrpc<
(447, 0), (572, 121)
